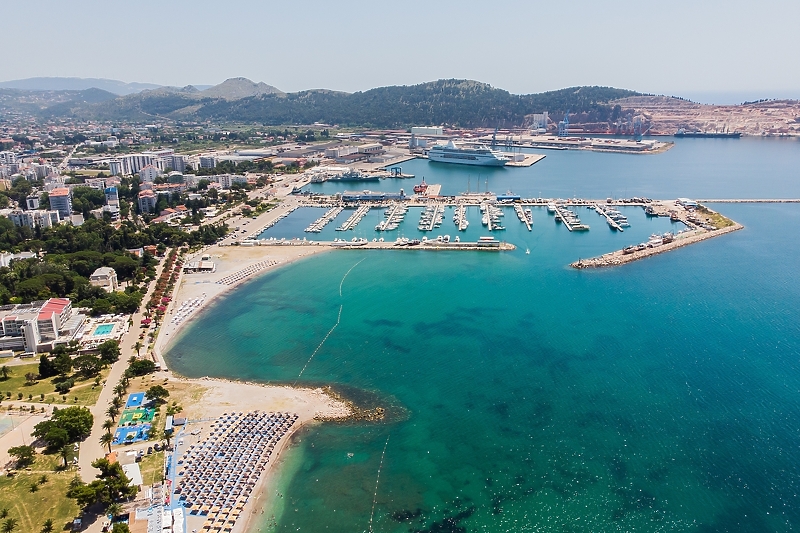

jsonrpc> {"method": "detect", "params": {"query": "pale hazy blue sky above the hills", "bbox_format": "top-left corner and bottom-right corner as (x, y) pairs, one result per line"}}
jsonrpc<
(0, 0), (800, 102)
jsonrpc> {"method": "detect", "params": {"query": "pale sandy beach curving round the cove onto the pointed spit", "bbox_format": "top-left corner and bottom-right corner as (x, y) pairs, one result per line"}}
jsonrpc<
(146, 239), (344, 532)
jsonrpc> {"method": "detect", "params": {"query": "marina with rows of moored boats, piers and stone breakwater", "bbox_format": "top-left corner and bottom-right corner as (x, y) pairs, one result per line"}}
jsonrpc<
(247, 193), (734, 268)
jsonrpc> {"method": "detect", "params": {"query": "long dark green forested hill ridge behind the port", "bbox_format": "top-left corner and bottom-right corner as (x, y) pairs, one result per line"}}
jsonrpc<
(45, 80), (639, 128)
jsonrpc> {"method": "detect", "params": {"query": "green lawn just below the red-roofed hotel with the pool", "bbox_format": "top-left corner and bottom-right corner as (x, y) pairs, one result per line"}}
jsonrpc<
(0, 363), (110, 405)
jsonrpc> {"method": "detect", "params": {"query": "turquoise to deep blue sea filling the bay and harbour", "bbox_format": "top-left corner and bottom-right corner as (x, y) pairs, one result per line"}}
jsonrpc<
(166, 138), (800, 533)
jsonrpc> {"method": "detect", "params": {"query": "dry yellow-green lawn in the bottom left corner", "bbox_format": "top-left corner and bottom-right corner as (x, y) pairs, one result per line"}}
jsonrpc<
(0, 454), (79, 533)
